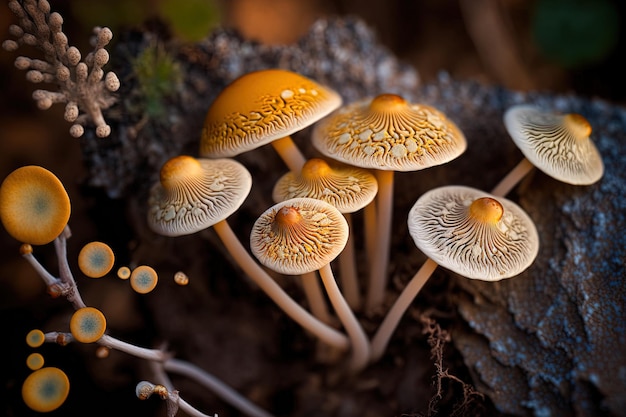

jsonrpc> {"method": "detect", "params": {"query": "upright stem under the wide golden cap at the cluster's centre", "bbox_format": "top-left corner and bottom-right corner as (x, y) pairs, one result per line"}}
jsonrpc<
(365, 170), (394, 313)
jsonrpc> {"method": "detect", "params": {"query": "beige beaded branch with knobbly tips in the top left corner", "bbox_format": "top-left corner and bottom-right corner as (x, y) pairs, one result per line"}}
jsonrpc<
(2, 0), (120, 138)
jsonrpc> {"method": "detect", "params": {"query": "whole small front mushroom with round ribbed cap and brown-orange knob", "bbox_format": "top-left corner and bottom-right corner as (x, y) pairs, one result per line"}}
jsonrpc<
(250, 198), (369, 372)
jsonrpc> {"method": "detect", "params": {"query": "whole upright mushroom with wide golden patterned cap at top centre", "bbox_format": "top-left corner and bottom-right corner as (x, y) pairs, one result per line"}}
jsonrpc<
(312, 94), (467, 312)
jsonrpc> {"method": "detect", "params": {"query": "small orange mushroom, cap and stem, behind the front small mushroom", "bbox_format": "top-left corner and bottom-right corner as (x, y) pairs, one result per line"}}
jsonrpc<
(273, 158), (378, 309)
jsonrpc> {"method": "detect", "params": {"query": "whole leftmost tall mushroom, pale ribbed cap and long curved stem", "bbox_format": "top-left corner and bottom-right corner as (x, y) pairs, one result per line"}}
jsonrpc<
(148, 155), (349, 350)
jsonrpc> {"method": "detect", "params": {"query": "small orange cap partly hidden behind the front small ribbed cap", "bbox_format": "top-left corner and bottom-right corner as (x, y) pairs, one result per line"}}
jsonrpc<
(272, 158), (378, 213)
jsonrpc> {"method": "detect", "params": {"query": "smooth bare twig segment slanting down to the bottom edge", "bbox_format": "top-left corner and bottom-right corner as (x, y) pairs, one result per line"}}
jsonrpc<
(163, 358), (272, 417)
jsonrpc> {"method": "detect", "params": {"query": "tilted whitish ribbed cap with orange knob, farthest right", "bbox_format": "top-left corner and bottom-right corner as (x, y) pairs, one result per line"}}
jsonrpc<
(504, 105), (604, 185)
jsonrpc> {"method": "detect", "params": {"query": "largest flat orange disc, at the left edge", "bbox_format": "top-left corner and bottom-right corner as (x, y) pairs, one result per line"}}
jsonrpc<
(0, 165), (71, 245)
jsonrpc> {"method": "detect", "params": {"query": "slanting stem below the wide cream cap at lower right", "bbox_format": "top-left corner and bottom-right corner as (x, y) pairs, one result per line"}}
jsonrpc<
(370, 258), (437, 362)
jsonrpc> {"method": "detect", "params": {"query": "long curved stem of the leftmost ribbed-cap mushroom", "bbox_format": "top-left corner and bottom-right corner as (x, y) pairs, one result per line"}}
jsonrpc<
(213, 220), (350, 350)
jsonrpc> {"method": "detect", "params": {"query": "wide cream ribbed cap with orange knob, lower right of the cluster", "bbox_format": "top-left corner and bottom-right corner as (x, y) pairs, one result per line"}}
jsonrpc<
(408, 186), (539, 281)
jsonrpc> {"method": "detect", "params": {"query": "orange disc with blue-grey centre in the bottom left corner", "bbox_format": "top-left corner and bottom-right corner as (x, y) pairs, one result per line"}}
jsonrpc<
(22, 367), (70, 413)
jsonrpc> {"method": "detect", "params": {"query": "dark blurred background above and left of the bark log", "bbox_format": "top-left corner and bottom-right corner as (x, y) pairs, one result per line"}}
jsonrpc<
(0, 0), (626, 417)
